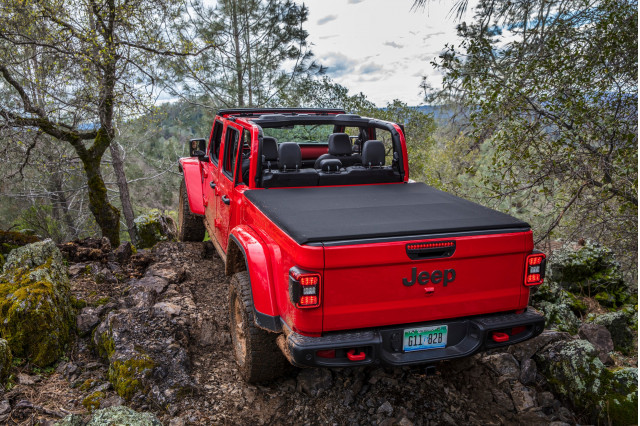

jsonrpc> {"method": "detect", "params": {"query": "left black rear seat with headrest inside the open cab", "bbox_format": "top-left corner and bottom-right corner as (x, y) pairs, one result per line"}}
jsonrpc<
(262, 142), (318, 188)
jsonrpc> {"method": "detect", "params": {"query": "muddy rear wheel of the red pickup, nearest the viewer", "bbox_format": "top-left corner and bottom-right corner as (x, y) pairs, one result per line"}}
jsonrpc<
(229, 271), (288, 383)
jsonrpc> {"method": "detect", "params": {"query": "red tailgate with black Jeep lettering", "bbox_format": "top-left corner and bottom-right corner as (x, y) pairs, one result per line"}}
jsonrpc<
(322, 231), (533, 332)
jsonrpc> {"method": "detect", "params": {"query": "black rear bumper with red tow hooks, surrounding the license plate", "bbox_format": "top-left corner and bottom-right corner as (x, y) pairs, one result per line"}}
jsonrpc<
(279, 308), (544, 367)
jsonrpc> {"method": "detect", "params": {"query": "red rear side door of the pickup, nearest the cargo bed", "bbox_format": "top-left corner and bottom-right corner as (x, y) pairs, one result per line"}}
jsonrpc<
(215, 123), (240, 252)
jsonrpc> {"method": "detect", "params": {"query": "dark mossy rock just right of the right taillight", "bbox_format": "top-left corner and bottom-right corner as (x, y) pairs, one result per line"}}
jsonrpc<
(549, 242), (630, 308)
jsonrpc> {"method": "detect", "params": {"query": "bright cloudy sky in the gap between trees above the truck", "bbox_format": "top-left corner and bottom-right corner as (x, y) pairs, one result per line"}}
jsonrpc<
(296, 0), (476, 106)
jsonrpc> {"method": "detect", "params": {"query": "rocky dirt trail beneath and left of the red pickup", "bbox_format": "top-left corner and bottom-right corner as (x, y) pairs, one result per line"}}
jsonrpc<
(0, 242), (637, 426)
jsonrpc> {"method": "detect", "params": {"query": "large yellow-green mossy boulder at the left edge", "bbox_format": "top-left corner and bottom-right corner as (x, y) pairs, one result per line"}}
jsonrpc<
(0, 240), (75, 367)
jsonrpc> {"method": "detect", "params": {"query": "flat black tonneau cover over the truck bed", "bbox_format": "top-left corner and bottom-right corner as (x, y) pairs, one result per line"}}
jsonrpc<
(245, 183), (529, 244)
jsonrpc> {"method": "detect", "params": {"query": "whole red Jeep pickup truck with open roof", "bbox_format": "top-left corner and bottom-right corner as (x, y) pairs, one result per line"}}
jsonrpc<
(179, 109), (545, 382)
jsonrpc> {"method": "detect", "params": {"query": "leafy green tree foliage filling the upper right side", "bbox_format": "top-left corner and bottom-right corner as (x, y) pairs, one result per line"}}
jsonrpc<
(436, 0), (638, 270)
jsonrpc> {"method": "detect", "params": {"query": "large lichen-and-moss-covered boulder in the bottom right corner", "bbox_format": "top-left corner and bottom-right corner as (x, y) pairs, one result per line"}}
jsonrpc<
(534, 340), (638, 424)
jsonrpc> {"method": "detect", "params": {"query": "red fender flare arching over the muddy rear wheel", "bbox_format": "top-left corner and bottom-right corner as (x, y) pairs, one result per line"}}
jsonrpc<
(227, 225), (282, 333)
